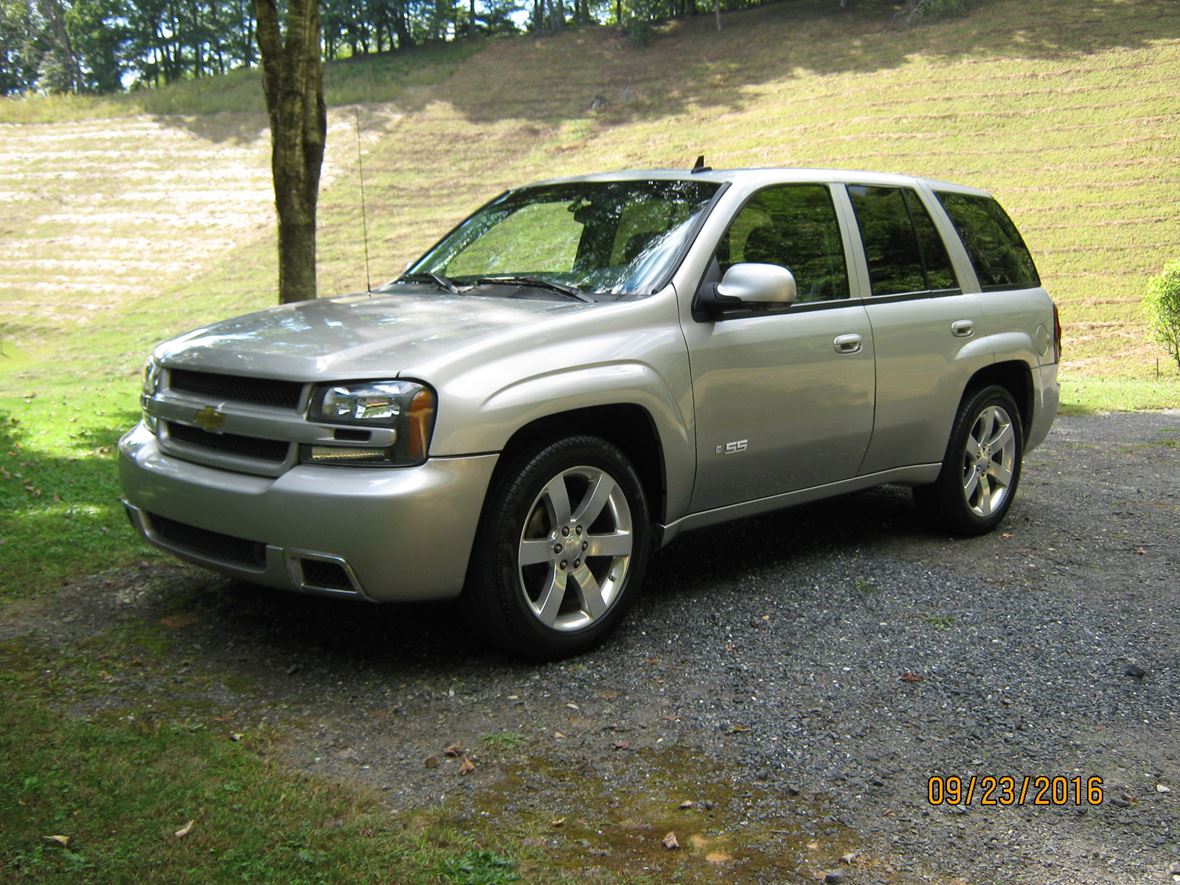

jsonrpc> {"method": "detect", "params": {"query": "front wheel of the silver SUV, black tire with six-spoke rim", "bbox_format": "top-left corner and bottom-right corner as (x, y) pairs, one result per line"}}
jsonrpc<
(463, 435), (650, 660)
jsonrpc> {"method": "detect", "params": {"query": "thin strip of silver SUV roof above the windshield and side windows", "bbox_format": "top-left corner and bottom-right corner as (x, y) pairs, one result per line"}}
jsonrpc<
(530, 166), (988, 196)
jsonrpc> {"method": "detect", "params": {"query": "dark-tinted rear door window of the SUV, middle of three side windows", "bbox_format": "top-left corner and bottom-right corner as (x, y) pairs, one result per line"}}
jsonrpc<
(848, 184), (958, 295)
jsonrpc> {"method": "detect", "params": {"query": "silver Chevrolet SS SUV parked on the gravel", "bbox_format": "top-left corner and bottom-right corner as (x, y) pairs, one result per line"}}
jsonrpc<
(119, 171), (1061, 657)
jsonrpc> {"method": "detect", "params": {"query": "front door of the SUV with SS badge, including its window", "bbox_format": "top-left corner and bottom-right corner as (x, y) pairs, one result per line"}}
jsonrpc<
(684, 184), (874, 512)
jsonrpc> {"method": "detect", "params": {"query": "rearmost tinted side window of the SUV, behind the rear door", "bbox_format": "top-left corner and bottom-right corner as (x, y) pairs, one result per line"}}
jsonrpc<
(937, 192), (1041, 291)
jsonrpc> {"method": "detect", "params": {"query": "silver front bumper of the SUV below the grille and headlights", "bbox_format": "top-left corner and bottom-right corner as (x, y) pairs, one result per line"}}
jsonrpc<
(119, 425), (497, 602)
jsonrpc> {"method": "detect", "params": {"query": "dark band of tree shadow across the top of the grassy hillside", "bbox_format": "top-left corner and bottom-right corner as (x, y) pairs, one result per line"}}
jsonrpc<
(139, 0), (1180, 140)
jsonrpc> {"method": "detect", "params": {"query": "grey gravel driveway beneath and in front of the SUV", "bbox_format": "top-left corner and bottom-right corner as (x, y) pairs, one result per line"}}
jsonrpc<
(0, 412), (1180, 885)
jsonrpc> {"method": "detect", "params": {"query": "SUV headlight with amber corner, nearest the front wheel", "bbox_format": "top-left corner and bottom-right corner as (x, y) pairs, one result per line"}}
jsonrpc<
(303, 381), (435, 466)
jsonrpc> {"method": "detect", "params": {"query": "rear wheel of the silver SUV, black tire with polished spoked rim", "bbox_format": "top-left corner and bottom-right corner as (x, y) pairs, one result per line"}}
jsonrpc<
(913, 385), (1024, 536)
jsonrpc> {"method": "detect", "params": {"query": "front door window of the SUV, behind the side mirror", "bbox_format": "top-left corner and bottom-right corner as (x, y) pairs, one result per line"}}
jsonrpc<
(717, 184), (848, 302)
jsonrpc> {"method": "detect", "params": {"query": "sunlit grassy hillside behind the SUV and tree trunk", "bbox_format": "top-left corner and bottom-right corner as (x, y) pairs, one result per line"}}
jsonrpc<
(0, 0), (1180, 592)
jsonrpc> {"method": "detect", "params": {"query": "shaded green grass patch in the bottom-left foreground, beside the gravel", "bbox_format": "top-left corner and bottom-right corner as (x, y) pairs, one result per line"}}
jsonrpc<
(0, 631), (536, 883)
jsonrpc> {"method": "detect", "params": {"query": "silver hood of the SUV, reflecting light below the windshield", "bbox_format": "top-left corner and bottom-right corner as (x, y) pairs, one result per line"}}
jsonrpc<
(155, 287), (595, 381)
